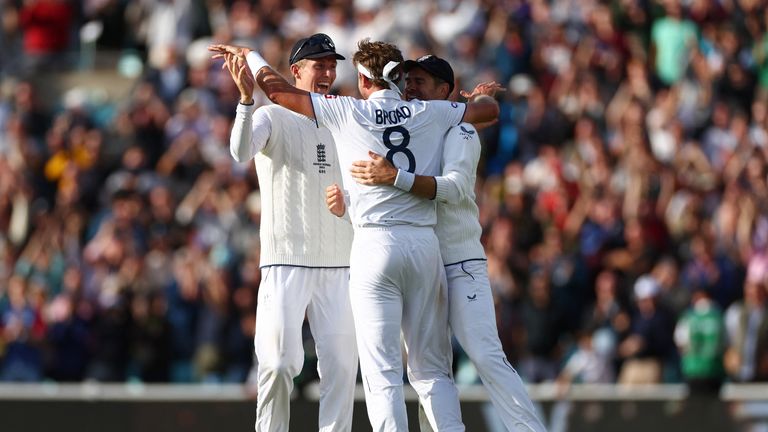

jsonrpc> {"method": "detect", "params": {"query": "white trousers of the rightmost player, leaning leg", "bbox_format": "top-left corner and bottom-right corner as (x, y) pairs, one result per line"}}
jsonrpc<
(445, 261), (546, 432)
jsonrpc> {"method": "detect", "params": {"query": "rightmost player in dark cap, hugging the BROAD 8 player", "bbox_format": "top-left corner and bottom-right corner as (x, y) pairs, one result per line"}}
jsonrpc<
(328, 55), (546, 432)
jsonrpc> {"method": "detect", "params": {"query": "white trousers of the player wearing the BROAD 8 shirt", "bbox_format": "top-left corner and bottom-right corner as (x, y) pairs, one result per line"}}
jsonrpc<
(350, 226), (464, 432)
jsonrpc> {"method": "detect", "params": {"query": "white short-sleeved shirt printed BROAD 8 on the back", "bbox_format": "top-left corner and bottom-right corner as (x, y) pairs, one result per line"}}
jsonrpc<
(312, 90), (465, 226)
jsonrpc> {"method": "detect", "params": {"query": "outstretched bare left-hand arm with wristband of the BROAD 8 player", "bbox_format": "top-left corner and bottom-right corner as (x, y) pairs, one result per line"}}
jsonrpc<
(208, 44), (315, 118)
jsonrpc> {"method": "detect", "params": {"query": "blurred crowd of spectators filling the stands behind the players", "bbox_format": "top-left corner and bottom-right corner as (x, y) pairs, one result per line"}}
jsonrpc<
(0, 0), (768, 390)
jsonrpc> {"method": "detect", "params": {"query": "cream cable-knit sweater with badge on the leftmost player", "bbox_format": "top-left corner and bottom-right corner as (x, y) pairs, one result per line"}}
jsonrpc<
(230, 104), (352, 268)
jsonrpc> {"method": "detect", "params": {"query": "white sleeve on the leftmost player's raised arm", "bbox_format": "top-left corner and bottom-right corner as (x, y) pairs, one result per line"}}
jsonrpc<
(229, 104), (272, 162)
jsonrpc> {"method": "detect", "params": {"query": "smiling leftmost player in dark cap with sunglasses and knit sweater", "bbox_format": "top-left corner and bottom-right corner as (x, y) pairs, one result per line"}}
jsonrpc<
(220, 34), (358, 432)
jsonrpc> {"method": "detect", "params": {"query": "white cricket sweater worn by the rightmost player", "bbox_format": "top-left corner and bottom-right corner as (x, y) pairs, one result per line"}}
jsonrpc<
(435, 123), (486, 265)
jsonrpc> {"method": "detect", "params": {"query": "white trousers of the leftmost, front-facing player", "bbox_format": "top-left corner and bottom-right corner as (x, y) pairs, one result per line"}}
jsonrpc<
(255, 266), (357, 432)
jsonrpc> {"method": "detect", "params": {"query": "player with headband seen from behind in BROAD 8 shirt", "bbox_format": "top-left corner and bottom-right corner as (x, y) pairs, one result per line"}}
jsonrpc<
(210, 39), (498, 431)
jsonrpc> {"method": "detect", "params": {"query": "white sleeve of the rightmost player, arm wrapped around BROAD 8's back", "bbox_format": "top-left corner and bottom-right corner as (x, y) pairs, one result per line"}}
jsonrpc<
(435, 123), (480, 204)
